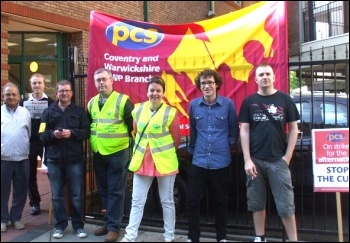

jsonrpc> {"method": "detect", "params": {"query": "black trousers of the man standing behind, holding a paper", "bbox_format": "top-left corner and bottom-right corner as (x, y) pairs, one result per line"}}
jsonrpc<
(28, 139), (43, 206)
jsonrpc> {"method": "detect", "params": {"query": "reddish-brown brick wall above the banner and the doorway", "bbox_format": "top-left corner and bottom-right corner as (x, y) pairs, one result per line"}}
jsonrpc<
(1, 1), (259, 90)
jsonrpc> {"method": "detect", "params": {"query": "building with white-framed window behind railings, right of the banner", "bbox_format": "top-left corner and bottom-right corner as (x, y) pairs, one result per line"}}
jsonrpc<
(287, 1), (349, 94)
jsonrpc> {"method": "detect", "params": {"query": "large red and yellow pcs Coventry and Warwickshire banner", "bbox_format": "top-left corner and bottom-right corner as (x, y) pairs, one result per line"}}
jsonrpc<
(86, 1), (289, 136)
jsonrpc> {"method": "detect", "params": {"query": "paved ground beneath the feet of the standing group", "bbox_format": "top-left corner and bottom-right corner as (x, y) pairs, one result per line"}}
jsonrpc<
(1, 168), (281, 242)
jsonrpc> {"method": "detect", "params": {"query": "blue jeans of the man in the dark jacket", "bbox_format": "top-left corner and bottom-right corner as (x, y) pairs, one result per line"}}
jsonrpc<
(47, 160), (84, 230)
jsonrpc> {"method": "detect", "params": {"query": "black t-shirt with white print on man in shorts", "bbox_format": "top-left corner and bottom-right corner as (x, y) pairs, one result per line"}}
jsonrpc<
(239, 91), (300, 161)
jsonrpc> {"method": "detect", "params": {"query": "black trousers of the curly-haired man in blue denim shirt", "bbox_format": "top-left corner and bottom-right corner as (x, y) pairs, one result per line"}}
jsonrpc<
(187, 165), (229, 242)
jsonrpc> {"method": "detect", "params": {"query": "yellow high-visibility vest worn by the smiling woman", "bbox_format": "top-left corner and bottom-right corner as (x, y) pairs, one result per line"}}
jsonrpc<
(129, 101), (179, 174)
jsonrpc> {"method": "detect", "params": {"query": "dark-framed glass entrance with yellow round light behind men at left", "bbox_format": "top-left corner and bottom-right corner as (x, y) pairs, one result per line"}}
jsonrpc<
(8, 32), (62, 99)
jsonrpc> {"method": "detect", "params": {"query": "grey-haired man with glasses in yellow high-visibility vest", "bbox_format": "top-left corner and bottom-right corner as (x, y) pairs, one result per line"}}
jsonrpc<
(87, 68), (134, 242)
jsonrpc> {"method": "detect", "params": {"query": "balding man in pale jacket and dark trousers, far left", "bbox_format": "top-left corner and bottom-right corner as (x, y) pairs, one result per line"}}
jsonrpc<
(1, 82), (31, 232)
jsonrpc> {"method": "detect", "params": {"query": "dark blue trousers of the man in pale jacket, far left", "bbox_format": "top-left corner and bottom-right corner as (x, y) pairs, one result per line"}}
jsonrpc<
(1, 159), (29, 223)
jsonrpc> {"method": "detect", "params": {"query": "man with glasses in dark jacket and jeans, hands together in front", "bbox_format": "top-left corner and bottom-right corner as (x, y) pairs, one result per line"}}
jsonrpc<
(39, 80), (90, 239)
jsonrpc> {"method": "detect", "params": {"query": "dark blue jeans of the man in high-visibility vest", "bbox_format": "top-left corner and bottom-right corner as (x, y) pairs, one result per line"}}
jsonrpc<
(93, 148), (129, 232)
